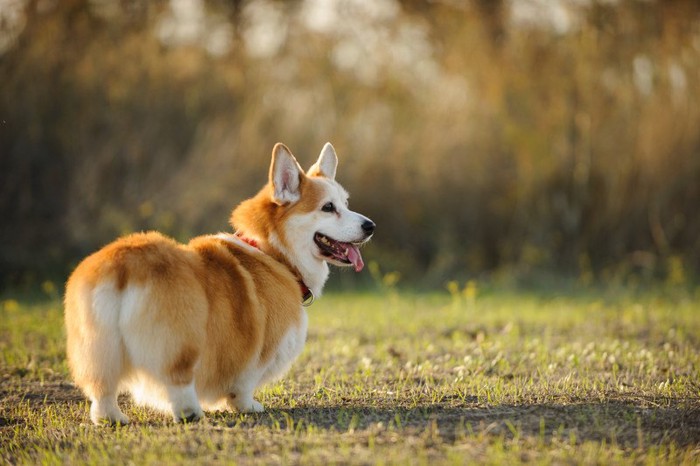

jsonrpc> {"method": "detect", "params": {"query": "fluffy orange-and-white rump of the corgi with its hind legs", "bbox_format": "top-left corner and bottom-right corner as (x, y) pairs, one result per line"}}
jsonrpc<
(65, 233), (207, 423)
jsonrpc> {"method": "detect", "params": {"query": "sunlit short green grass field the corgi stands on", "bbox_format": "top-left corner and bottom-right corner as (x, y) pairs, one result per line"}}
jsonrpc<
(0, 285), (700, 465)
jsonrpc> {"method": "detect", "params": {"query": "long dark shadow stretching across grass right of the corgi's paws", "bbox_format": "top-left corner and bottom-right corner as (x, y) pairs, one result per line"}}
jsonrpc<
(237, 400), (700, 448)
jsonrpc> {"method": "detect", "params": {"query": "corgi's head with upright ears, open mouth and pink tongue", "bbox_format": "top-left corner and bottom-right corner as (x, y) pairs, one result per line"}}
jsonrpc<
(231, 143), (375, 284)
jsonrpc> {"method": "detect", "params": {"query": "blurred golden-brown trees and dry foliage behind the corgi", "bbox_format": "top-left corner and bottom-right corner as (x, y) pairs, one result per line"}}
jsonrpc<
(0, 0), (700, 287)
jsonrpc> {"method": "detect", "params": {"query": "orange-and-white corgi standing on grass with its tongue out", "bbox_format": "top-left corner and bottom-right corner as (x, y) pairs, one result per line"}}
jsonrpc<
(65, 143), (375, 425)
